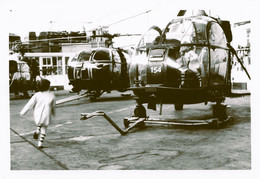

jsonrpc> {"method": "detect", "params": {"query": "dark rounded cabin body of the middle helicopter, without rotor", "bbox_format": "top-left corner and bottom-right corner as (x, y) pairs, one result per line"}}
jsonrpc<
(68, 48), (129, 92)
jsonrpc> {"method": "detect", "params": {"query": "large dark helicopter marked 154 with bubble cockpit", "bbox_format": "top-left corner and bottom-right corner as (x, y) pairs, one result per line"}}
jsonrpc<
(120, 10), (251, 127)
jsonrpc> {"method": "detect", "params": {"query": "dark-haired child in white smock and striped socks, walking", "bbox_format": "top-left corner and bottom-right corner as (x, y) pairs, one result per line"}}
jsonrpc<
(20, 79), (56, 148)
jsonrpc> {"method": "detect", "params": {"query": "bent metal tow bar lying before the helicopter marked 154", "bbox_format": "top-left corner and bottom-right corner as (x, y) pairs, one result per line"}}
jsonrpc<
(80, 111), (146, 135)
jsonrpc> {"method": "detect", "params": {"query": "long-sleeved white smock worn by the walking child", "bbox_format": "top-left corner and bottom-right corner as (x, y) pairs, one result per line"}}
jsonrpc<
(20, 91), (56, 126)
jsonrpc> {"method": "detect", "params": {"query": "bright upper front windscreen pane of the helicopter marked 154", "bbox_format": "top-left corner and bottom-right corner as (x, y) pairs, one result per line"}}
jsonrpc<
(165, 21), (195, 43)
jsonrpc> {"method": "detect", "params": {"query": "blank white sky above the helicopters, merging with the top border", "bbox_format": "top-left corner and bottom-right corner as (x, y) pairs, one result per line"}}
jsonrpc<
(3, 0), (259, 45)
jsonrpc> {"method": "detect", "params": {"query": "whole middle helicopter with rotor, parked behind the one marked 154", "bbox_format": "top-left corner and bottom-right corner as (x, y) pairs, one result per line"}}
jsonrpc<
(68, 32), (140, 100)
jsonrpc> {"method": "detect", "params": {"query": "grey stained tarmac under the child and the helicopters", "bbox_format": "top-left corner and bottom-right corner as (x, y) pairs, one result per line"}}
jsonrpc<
(10, 91), (251, 171)
